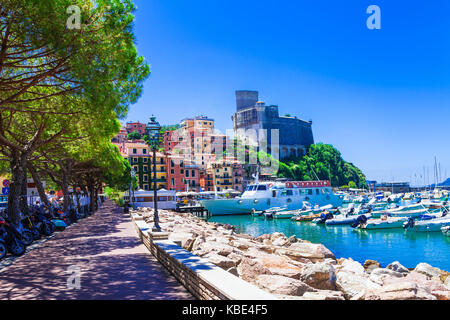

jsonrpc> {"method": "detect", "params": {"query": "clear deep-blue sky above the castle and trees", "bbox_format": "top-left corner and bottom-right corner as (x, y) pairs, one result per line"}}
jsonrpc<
(125, 0), (450, 184)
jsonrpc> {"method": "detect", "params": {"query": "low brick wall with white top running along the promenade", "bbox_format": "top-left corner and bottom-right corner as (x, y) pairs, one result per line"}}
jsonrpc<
(131, 213), (276, 300)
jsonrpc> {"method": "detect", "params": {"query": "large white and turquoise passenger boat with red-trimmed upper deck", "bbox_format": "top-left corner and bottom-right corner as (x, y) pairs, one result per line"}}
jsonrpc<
(200, 180), (343, 215)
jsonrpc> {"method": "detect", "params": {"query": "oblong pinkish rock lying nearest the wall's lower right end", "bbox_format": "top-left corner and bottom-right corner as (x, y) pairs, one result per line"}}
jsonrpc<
(255, 275), (315, 296)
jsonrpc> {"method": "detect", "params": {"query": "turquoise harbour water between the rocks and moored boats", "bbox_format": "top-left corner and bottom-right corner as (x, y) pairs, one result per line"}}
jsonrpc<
(208, 215), (450, 271)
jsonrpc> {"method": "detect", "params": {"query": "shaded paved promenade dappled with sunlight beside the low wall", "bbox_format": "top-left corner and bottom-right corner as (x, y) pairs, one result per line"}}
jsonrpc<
(0, 200), (194, 300)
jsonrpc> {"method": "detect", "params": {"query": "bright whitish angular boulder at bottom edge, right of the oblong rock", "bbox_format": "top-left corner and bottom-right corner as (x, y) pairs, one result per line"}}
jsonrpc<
(336, 266), (380, 299)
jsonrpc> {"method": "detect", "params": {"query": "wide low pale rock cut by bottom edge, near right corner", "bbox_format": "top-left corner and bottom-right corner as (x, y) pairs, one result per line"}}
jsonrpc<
(364, 281), (436, 300)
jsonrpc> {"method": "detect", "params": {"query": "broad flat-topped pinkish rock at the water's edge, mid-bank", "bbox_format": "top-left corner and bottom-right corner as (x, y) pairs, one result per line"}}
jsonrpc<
(275, 242), (335, 262)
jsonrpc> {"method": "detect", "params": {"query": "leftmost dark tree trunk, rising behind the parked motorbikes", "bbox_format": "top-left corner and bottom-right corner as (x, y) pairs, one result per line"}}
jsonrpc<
(7, 150), (27, 223)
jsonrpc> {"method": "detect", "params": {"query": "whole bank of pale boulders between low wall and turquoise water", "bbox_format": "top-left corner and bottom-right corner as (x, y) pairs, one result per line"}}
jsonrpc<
(134, 208), (450, 300)
